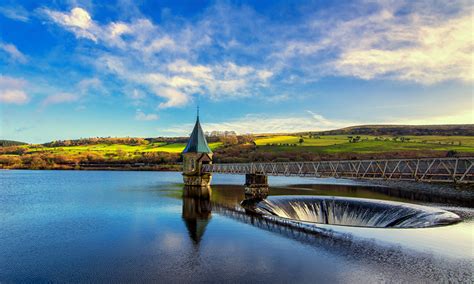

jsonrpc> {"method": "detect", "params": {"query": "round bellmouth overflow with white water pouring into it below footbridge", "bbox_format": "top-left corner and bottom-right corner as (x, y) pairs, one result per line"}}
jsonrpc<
(247, 196), (461, 228)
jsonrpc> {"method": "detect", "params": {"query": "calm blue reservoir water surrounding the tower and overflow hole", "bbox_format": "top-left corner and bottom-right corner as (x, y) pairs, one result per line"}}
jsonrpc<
(0, 171), (474, 283)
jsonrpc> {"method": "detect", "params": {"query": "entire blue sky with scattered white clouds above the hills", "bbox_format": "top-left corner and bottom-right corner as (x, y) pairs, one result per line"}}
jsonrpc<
(0, 0), (474, 143)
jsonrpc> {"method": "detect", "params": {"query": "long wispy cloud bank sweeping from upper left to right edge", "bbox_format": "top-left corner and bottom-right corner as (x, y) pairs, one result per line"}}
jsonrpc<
(42, 1), (474, 113)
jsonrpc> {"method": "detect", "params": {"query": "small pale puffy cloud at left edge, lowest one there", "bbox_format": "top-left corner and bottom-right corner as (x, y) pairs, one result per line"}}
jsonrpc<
(0, 75), (30, 104)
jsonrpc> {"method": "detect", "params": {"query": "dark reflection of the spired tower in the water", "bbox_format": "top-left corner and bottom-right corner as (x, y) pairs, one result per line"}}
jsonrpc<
(182, 187), (211, 245)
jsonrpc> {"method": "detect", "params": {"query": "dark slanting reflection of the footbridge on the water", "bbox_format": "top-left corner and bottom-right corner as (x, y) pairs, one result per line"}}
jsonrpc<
(212, 203), (472, 282)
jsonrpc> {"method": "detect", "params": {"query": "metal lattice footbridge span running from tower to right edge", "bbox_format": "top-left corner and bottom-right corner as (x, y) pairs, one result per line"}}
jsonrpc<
(202, 157), (474, 183)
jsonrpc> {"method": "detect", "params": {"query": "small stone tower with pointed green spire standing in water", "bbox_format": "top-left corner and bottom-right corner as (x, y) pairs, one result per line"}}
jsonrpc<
(182, 113), (212, 187)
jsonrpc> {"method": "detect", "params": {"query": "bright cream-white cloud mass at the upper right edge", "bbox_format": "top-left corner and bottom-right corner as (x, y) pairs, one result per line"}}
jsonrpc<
(330, 13), (474, 84)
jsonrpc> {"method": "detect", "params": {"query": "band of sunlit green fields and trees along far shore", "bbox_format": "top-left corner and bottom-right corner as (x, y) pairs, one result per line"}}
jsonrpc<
(0, 133), (474, 170)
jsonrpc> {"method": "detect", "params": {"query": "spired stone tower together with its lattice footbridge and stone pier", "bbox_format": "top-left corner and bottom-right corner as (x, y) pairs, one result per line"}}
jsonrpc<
(182, 114), (474, 196)
